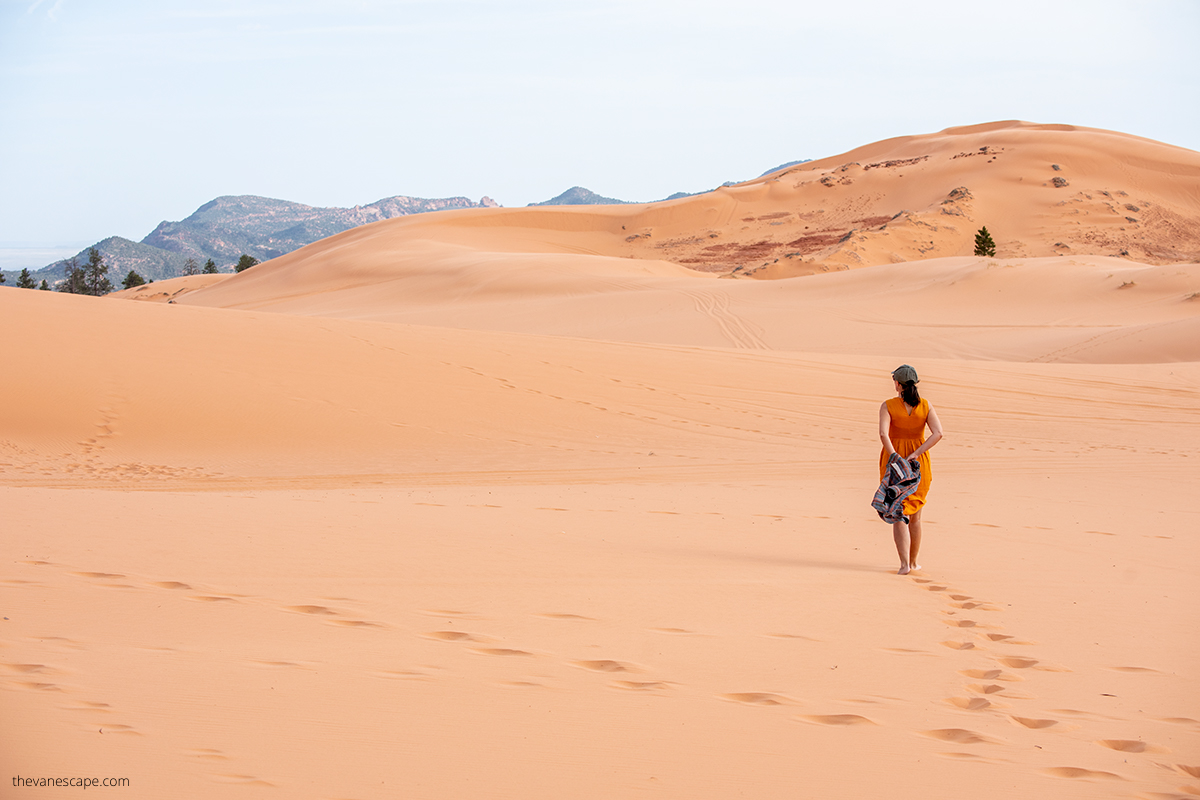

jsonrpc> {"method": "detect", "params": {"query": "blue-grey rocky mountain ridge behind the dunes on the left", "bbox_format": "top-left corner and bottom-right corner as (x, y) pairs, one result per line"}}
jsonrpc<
(15, 194), (497, 287)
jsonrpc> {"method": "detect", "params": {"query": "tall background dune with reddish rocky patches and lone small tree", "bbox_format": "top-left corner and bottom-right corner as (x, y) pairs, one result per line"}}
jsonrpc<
(162, 122), (1200, 289)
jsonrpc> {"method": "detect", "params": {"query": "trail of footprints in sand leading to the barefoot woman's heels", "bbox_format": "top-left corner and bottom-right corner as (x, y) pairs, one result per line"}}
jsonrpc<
(913, 577), (1200, 796)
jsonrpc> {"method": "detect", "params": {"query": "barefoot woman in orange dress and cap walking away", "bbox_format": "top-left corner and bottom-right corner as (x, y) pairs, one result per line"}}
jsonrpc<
(880, 363), (942, 575)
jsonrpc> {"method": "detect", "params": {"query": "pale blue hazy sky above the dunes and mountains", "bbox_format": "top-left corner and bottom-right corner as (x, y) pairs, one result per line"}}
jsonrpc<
(0, 0), (1200, 253)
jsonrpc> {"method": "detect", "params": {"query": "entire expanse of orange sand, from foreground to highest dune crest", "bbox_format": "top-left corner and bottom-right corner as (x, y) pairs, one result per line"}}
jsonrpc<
(7, 124), (1200, 800)
